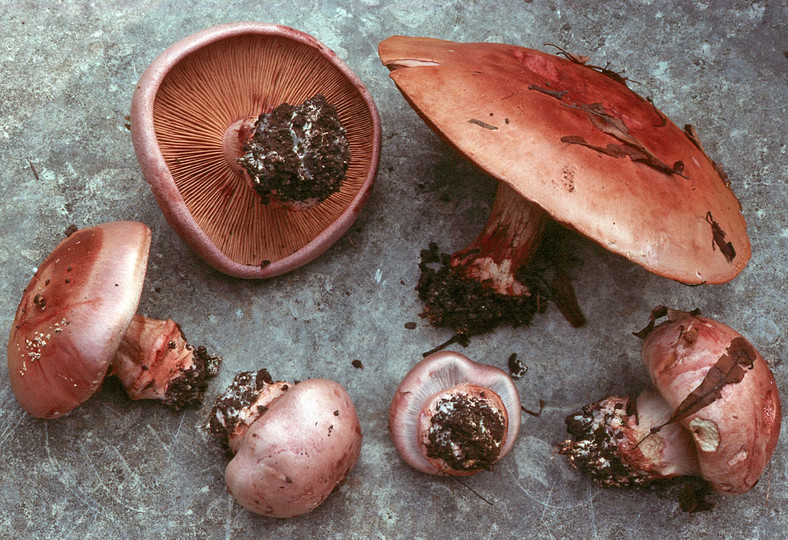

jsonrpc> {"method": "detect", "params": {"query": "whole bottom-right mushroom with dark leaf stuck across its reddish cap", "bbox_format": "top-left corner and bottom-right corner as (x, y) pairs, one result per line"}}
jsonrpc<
(559, 307), (782, 494)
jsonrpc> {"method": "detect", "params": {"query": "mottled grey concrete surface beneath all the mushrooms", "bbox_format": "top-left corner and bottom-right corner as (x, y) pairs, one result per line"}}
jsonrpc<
(0, 0), (788, 539)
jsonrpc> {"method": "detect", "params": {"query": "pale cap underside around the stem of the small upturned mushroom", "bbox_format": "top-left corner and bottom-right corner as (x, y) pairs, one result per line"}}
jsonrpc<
(389, 351), (520, 475)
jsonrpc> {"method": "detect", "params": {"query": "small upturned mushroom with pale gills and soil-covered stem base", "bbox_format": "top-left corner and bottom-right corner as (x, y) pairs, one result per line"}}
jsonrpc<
(389, 351), (520, 476)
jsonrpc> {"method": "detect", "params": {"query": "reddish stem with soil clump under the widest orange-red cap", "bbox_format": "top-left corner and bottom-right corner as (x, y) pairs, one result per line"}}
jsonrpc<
(416, 182), (585, 336)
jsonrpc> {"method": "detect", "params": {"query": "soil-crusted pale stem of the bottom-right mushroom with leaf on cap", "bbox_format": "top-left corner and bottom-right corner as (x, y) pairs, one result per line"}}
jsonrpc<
(558, 387), (700, 487)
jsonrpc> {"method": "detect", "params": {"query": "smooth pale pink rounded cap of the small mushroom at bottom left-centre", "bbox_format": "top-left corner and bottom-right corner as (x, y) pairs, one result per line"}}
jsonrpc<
(224, 379), (361, 518)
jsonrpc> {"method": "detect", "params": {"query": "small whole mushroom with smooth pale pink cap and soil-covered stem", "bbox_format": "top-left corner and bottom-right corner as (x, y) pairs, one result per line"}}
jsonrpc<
(207, 369), (361, 518)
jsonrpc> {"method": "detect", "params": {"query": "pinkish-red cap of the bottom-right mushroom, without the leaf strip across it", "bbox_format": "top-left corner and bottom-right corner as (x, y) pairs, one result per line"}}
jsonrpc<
(643, 316), (782, 494)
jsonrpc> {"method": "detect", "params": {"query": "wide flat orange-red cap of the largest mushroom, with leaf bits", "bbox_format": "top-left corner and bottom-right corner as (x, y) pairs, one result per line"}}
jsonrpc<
(378, 36), (750, 284)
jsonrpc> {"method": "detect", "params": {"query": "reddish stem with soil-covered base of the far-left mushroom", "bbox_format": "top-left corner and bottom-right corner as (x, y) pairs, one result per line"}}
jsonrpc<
(112, 315), (221, 410)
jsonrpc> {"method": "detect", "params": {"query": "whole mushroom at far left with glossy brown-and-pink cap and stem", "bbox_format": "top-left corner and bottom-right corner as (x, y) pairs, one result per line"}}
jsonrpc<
(8, 221), (219, 418)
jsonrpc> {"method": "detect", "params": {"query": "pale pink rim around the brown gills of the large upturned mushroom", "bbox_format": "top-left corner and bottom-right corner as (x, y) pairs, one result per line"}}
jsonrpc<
(131, 21), (381, 279)
